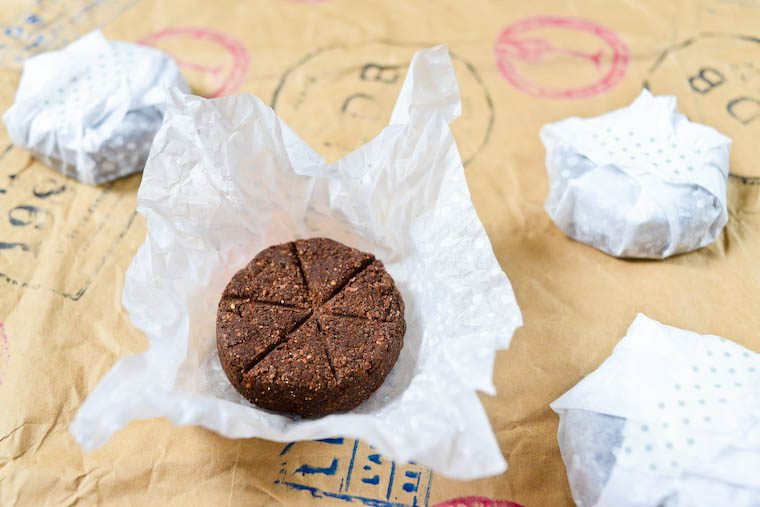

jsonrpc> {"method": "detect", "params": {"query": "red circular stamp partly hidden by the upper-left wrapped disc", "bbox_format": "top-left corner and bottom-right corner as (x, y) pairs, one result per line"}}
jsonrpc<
(138, 27), (250, 98)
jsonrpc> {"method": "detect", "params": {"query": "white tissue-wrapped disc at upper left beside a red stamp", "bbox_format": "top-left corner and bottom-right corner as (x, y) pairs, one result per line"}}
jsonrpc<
(3, 31), (188, 184)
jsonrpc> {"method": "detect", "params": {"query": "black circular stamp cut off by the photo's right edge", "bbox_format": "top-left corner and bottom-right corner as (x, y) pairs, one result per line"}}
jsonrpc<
(644, 33), (760, 185)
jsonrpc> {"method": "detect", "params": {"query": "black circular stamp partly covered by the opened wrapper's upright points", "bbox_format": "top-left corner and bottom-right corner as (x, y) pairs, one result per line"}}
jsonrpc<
(271, 41), (494, 166)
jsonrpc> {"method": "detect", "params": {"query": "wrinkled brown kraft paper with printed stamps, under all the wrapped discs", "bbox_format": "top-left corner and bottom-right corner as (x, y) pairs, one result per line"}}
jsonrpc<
(0, 0), (760, 505)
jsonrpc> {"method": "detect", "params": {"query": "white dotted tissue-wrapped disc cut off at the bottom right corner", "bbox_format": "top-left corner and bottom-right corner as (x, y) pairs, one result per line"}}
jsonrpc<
(551, 314), (760, 507)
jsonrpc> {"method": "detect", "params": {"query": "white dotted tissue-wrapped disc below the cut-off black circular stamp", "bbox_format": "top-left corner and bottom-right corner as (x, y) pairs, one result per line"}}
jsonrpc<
(541, 90), (731, 259)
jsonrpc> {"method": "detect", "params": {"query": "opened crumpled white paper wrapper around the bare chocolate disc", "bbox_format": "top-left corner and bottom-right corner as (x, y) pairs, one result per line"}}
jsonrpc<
(72, 46), (521, 479)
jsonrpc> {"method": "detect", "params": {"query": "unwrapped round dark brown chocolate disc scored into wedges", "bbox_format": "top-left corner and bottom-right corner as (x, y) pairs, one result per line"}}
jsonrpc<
(216, 238), (406, 417)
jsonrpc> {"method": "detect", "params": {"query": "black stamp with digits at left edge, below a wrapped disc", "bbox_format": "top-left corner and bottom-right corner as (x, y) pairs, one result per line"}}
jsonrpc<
(0, 151), (139, 301)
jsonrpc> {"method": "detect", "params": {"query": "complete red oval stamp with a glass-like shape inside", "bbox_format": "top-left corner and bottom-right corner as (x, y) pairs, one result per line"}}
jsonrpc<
(494, 16), (628, 99)
